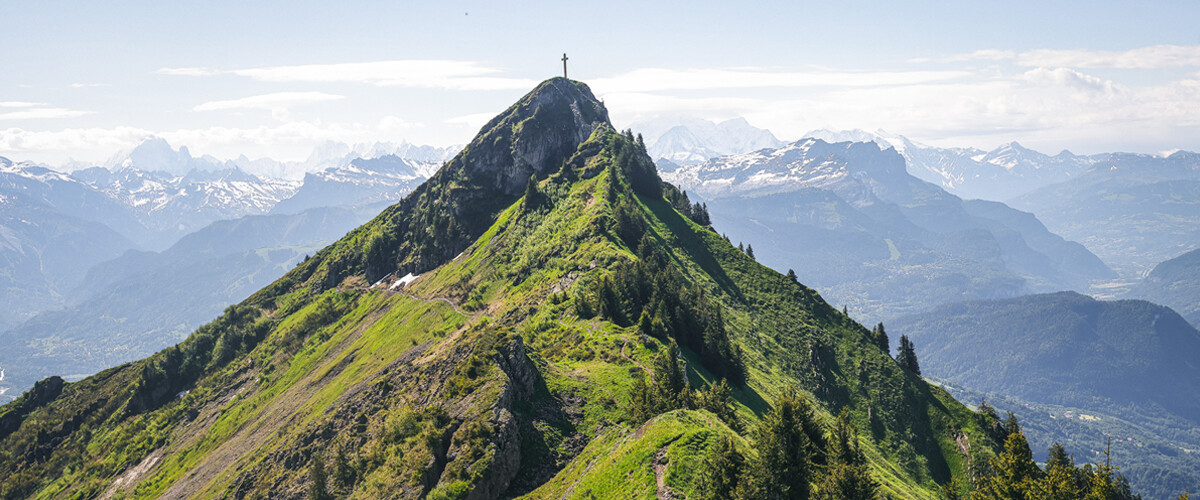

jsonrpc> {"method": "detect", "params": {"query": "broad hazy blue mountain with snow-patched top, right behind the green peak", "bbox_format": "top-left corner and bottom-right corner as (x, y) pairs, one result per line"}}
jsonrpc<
(662, 139), (1115, 321)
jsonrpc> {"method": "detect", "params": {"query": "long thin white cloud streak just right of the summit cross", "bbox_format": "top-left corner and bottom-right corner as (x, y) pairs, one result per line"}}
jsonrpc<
(592, 67), (971, 92)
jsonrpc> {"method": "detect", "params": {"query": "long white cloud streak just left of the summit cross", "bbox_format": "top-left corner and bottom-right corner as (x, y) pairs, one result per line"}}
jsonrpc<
(156, 60), (538, 90)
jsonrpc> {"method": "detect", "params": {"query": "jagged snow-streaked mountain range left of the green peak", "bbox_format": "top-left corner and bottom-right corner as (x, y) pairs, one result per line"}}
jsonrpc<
(0, 138), (456, 249)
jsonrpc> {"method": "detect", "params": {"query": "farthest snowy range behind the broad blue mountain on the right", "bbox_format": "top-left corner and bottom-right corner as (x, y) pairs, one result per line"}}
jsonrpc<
(638, 119), (1200, 282)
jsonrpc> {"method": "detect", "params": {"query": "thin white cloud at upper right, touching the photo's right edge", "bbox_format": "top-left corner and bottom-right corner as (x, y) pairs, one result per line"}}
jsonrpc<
(941, 44), (1200, 70)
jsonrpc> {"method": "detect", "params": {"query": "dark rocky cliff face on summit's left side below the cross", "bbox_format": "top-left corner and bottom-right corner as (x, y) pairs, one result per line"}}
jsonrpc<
(296, 78), (611, 288)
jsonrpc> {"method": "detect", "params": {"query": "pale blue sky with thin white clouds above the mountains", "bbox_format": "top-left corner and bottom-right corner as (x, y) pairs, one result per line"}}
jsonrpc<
(0, 0), (1200, 162)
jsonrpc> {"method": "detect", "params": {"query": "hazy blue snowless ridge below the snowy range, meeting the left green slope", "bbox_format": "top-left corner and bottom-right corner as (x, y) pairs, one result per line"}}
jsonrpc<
(0, 204), (385, 393)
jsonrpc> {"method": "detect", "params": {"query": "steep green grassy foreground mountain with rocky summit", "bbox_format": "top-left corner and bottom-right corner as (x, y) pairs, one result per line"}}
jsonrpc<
(0, 79), (995, 499)
